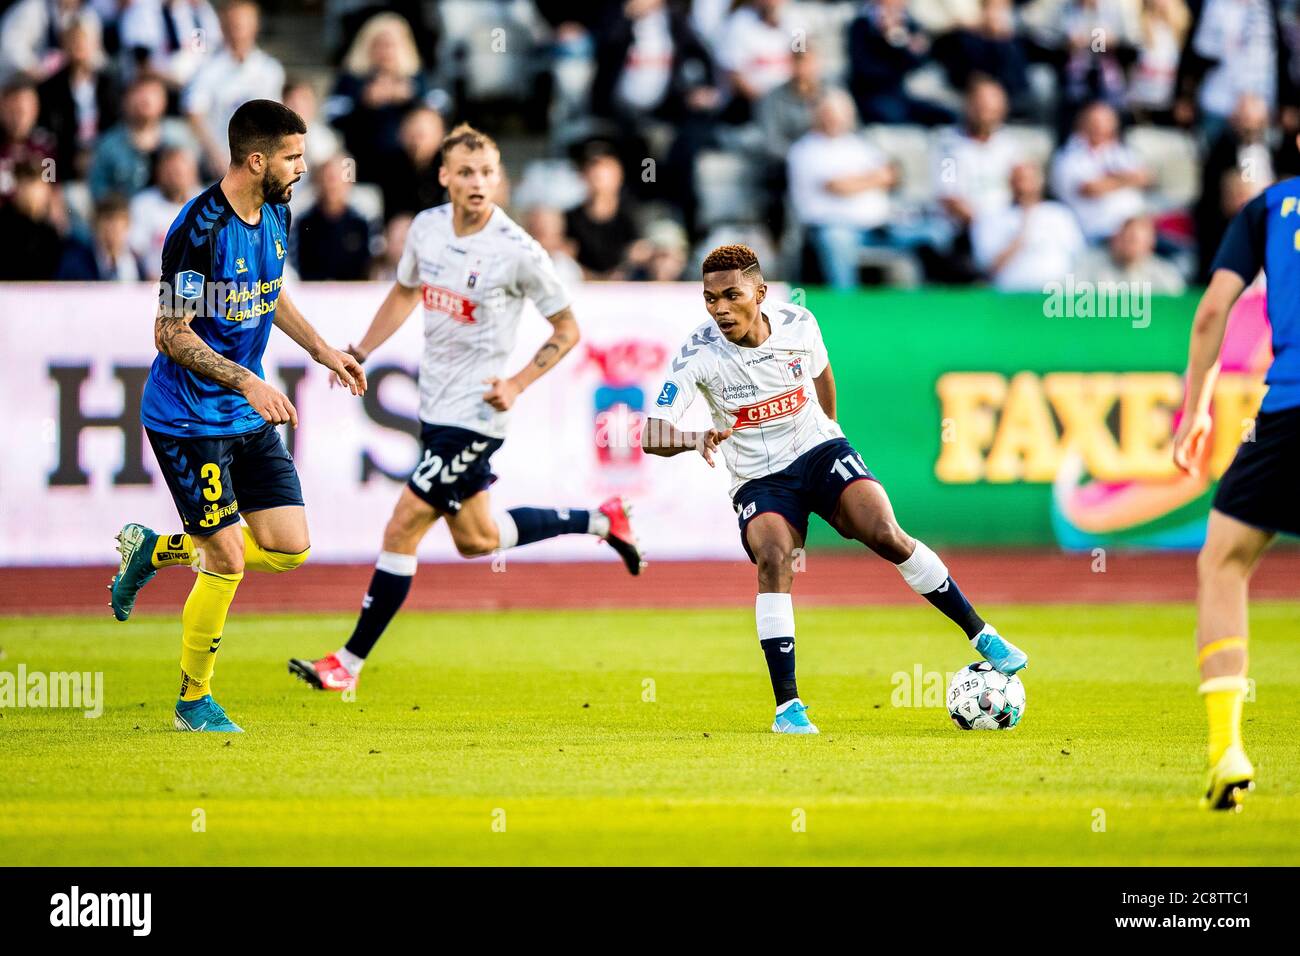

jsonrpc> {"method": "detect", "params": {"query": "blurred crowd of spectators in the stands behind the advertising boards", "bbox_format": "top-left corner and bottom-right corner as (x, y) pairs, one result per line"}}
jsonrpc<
(0, 0), (1300, 293)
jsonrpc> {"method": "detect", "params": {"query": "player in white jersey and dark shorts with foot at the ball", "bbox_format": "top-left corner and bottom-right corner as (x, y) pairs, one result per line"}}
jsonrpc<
(641, 246), (1028, 734)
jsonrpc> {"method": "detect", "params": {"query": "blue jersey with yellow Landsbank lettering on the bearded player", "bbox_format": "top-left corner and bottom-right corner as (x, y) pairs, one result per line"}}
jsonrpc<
(140, 182), (289, 438)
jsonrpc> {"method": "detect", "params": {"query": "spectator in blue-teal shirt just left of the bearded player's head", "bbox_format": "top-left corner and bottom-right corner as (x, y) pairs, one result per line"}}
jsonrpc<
(88, 74), (190, 199)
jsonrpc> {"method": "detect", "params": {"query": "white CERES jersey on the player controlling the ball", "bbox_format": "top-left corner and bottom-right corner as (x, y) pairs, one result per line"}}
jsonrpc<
(646, 302), (844, 494)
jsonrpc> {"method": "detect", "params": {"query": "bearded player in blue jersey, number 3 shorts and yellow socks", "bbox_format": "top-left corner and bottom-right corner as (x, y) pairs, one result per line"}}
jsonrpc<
(109, 100), (365, 732)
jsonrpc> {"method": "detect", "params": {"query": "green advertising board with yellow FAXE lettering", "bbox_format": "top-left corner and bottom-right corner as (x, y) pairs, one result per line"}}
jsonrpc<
(805, 290), (1266, 549)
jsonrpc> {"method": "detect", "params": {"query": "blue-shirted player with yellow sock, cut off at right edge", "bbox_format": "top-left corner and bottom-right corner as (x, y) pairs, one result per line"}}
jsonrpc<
(1174, 147), (1300, 810)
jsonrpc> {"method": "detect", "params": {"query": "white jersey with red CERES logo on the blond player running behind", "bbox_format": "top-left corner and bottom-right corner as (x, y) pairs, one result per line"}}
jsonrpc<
(397, 203), (569, 438)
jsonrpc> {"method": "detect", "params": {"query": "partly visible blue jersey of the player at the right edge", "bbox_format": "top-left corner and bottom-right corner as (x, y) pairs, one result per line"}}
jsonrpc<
(1210, 178), (1300, 412)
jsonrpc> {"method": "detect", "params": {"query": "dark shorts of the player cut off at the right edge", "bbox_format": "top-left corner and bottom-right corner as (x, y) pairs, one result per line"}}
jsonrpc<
(1214, 408), (1300, 535)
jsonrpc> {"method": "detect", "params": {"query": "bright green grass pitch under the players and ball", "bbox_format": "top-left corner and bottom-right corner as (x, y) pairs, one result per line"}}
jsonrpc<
(0, 604), (1300, 866)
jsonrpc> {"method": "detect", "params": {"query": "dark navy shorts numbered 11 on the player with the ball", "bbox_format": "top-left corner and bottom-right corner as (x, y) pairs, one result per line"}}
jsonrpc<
(732, 438), (878, 563)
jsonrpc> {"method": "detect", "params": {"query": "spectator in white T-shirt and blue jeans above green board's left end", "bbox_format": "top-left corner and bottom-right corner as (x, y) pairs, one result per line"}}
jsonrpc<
(789, 90), (898, 289)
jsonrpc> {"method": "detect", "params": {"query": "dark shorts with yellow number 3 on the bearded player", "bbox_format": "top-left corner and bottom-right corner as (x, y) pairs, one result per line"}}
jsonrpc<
(144, 423), (303, 535)
